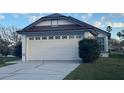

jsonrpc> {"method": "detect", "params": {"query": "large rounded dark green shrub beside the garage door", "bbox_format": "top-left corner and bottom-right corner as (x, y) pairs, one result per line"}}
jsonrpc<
(79, 39), (100, 62)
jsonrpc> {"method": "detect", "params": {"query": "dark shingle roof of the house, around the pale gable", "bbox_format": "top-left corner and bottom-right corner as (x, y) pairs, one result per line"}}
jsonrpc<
(17, 13), (111, 38)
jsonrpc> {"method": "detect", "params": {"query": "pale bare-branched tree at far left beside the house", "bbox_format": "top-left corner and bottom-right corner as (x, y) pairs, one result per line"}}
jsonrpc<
(0, 26), (21, 55)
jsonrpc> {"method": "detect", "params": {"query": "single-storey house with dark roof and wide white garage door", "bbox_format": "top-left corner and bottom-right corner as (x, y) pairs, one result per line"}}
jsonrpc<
(17, 13), (110, 61)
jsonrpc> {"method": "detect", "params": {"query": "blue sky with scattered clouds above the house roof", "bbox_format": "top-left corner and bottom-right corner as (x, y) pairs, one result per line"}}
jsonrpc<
(0, 13), (124, 38)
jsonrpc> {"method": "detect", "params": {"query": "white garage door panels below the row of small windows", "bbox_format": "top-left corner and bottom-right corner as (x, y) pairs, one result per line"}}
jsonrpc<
(27, 39), (80, 60)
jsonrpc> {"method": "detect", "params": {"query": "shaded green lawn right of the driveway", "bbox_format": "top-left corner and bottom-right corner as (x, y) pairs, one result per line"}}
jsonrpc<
(65, 54), (124, 80)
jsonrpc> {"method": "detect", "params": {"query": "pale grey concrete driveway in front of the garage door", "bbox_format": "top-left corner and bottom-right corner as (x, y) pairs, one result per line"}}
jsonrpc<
(0, 61), (80, 80)
